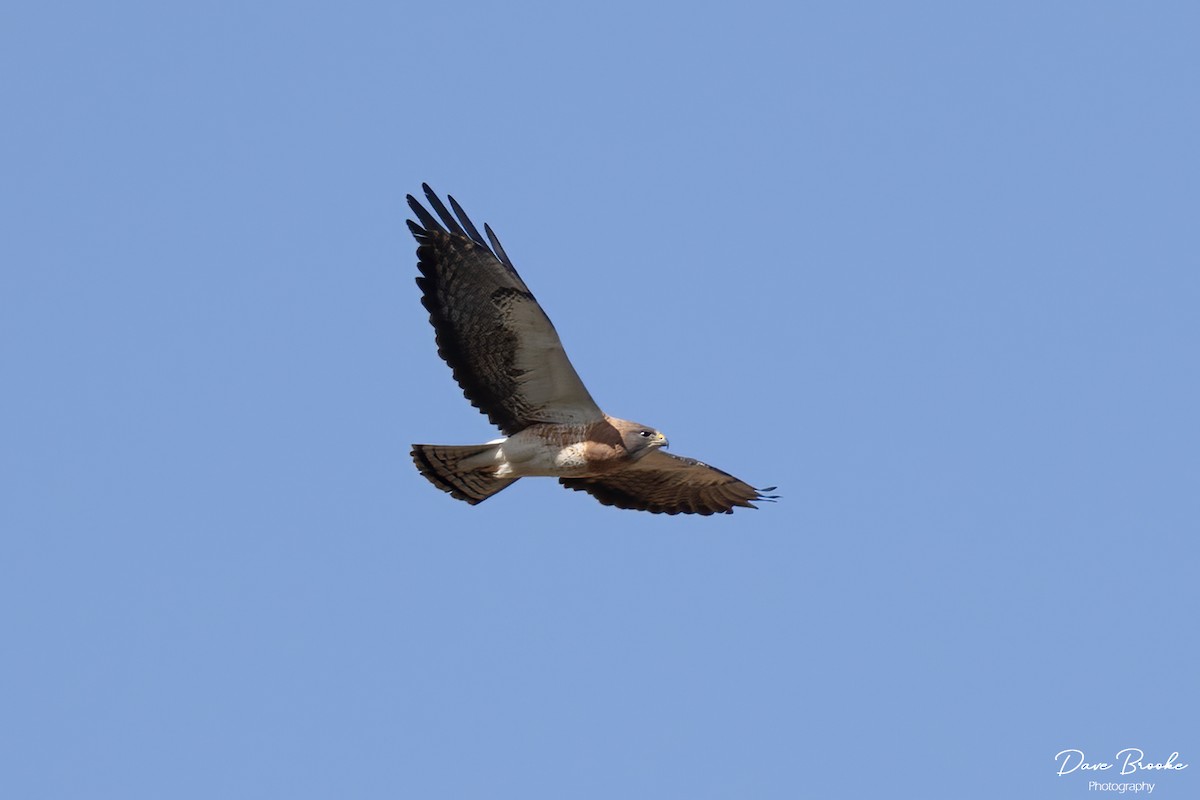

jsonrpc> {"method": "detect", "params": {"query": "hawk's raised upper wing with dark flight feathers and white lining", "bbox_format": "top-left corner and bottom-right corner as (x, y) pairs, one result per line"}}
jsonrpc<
(408, 184), (604, 435)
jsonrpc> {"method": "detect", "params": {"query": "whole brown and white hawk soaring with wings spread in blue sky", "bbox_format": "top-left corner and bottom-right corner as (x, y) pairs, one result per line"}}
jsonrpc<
(408, 184), (776, 516)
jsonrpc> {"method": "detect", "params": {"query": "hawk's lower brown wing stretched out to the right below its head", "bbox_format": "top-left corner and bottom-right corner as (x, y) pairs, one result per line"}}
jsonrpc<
(558, 450), (776, 516)
